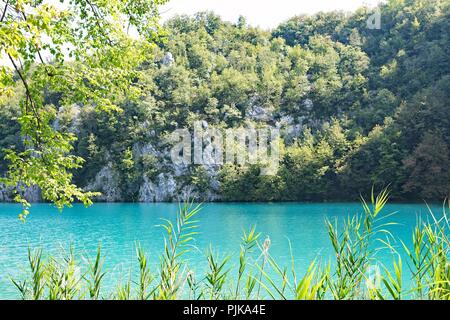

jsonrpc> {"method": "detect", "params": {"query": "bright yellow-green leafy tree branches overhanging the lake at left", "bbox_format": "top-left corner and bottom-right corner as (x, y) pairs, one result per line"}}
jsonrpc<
(0, 0), (165, 218)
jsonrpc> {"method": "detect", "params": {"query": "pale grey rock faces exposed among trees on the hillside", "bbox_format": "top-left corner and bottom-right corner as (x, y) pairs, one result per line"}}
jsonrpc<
(0, 107), (313, 202)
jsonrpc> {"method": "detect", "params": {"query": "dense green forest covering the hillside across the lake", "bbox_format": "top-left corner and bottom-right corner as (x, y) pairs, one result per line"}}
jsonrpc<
(0, 0), (450, 201)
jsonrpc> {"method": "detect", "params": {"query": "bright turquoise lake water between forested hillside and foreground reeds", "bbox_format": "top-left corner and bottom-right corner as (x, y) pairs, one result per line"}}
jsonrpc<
(0, 203), (442, 299)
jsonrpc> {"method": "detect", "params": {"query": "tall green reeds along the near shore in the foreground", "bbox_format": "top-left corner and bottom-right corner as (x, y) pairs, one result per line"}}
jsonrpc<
(12, 191), (450, 300)
